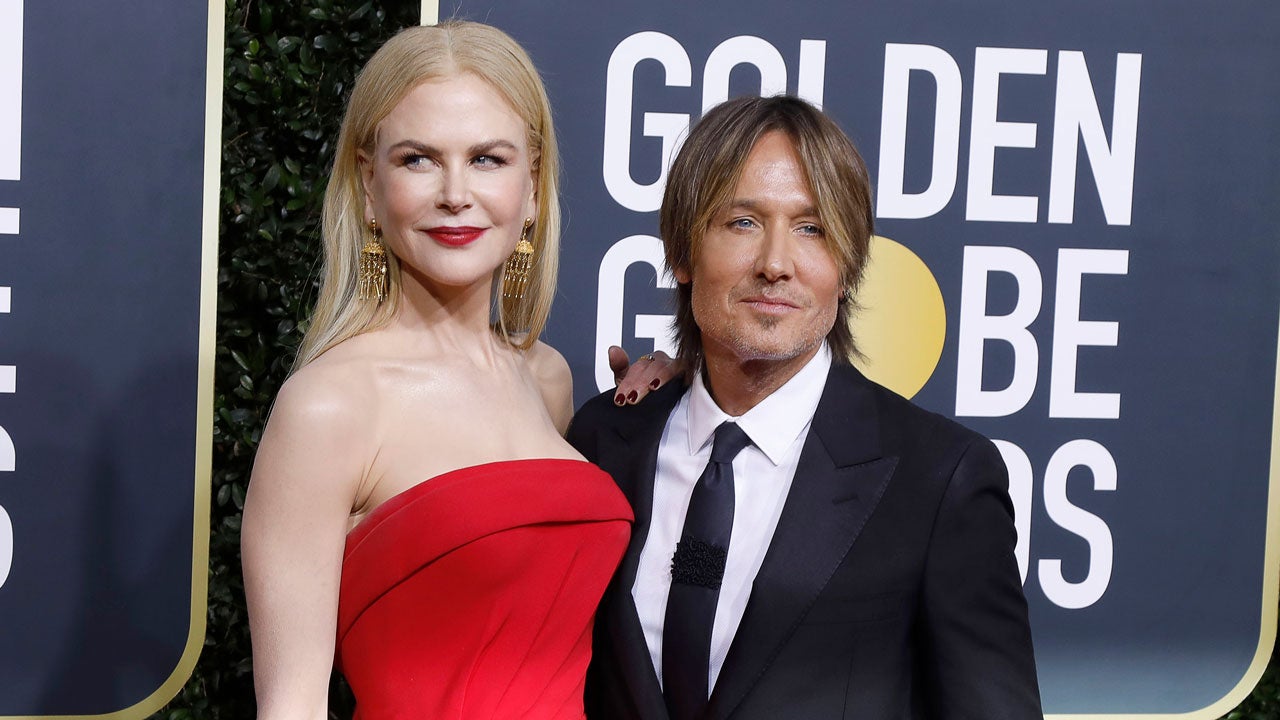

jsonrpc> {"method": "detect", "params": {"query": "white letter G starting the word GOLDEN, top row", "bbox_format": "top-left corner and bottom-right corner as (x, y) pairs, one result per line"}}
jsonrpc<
(604, 31), (692, 213)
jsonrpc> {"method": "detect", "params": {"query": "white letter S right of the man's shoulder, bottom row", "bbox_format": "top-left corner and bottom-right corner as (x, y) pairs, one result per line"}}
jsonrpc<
(1038, 439), (1116, 610)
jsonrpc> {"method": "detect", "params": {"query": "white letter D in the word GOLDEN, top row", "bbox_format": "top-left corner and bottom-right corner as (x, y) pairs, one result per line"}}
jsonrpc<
(876, 42), (963, 219)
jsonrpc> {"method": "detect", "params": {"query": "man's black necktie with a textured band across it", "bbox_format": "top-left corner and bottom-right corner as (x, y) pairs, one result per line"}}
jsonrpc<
(662, 421), (751, 720)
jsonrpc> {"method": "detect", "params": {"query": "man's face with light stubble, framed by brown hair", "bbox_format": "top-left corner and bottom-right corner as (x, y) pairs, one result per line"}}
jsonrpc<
(675, 132), (841, 369)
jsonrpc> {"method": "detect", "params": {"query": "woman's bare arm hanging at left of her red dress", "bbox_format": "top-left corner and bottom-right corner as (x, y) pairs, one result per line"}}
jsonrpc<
(241, 370), (371, 720)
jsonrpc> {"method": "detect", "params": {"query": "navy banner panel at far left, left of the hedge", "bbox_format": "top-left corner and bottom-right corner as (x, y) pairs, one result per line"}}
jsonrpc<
(0, 0), (224, 717)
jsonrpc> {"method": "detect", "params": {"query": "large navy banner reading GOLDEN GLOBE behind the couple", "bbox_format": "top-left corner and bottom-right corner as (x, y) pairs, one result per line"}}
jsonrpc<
(439, 0), (1280, 719)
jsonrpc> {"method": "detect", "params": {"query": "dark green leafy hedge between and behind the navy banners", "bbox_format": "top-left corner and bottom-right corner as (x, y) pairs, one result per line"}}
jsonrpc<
(152, 0), (1280, 720)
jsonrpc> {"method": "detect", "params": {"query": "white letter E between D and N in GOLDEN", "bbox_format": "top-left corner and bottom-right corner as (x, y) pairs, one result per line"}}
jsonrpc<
(965, 47), (1048, 223)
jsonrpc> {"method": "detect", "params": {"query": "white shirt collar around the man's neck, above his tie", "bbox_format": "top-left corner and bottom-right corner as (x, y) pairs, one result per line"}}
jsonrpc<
(689, 342), (831, 465)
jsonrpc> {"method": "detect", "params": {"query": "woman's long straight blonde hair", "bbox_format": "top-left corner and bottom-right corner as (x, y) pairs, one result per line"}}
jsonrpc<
(293, 20), (559, 370)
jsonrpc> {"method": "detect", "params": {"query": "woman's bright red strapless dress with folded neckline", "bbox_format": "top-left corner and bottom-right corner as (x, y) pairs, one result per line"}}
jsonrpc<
(337, 460), (631, 720)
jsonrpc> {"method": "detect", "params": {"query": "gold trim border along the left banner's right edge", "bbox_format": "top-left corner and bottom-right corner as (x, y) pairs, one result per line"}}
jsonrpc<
(3, 0), (225, 720)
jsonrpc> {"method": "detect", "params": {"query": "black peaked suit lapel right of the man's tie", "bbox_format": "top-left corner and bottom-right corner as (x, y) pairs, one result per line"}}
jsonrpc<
(704, 365), (897, 720)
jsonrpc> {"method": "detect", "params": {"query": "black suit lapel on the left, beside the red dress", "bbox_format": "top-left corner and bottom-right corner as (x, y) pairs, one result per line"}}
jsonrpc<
(600, 383), (685, 719)
